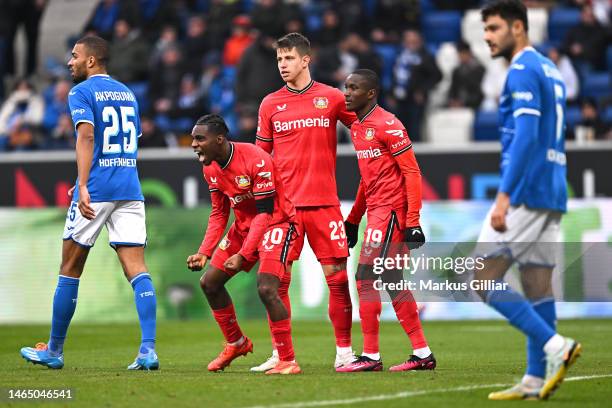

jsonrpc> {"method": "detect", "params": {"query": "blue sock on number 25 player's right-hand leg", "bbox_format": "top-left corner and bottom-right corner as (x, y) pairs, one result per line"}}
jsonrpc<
(130, 272), (157, 354)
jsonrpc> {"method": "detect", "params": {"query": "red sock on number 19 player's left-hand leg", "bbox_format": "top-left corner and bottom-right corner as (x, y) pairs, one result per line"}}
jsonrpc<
(357, 280), (382, 354)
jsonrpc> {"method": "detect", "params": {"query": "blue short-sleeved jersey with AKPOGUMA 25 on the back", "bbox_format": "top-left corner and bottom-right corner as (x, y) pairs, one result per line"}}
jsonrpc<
(68, 75), (144, 202)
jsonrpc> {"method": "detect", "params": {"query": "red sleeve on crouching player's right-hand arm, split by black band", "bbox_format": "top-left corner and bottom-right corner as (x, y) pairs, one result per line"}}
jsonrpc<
(239, 152), (276, 261)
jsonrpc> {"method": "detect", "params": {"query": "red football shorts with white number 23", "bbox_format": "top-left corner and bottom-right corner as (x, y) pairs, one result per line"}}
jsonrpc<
(289, 206), (348, 261)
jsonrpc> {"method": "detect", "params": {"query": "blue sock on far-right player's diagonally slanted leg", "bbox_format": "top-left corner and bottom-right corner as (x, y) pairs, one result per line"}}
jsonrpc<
(486, 288), (555, 347)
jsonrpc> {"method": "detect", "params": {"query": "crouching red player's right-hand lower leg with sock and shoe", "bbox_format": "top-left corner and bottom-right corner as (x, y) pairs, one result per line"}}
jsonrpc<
(257, 272), (301, 374)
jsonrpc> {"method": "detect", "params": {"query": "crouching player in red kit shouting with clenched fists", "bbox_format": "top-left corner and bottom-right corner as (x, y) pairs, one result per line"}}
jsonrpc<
(187, 115), (301, 374)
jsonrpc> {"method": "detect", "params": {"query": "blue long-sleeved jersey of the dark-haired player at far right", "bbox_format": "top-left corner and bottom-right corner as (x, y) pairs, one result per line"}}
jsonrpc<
(499, 47), (567, 212)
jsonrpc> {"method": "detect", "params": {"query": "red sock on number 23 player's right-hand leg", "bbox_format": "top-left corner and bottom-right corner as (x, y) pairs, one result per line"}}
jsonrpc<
(325, 269), (353, 347)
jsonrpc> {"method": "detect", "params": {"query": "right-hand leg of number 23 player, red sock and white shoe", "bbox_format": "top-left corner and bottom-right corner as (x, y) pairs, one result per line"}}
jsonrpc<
(321, 258), (355, 368)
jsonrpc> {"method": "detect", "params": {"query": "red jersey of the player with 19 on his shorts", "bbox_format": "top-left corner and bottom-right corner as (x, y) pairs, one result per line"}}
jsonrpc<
(351, 105), (421, 218)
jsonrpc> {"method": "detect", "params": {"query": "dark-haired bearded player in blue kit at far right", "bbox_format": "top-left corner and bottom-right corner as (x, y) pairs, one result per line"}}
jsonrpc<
(474, 0), (582, 400)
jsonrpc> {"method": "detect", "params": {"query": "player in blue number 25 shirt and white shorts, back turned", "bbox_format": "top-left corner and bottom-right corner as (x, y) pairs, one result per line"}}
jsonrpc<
(21, 36), (159, 370)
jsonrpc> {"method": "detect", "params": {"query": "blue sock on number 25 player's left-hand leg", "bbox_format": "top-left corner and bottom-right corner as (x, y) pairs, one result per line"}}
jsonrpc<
(48, 275), (79, 355)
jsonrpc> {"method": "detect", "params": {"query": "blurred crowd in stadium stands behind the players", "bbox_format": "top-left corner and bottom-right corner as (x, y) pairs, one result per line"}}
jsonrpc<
(0, 0), (612, 151)
